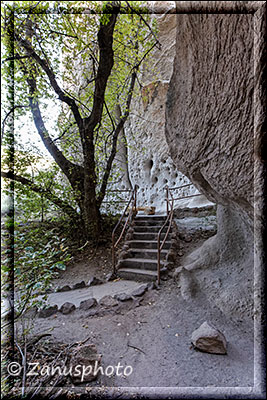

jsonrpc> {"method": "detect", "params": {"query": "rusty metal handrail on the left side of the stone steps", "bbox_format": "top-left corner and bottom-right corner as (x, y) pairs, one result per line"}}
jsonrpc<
(112, 185), (137, 274)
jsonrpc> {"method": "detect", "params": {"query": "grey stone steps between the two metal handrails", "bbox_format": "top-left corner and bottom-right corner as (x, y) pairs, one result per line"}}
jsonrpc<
(117, 215), (175, 282)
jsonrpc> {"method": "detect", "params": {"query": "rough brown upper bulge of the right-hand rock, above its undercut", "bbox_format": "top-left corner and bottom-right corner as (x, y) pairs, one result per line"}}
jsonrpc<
(166, 14), (253, 216)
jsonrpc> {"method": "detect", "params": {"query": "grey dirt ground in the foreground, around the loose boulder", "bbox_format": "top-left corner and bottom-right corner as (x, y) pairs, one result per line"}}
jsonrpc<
(24, 214), (254, 393)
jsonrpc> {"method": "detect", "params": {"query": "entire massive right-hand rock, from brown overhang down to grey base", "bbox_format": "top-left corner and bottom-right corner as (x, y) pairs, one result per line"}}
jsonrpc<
(166, 8), (254, 315)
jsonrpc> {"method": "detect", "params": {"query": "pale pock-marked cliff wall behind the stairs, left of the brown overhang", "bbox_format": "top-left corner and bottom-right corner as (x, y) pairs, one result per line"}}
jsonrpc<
(125, 2), (213, 212)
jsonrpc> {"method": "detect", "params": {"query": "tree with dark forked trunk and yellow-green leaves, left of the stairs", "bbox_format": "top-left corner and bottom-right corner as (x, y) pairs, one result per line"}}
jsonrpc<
(2, 1), (159, 237)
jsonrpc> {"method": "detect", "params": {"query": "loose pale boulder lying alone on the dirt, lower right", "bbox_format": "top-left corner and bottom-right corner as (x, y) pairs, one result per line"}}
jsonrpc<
(191, 321), (227, 354)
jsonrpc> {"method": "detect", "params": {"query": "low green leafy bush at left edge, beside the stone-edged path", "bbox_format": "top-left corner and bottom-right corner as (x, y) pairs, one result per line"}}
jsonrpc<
(2, 223), (71, 315)
